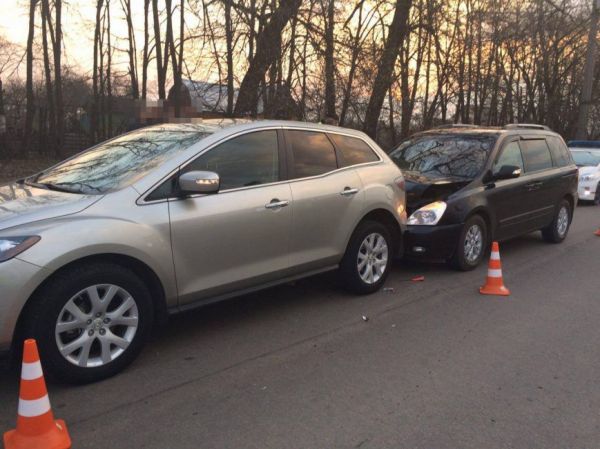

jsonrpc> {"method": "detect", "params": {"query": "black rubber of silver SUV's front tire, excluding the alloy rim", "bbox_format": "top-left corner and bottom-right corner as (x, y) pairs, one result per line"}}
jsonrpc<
(23, 264), (154, 384)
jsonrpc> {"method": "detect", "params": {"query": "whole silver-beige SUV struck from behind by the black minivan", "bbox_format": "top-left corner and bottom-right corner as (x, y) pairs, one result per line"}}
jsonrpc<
(0, 120), (406, 382)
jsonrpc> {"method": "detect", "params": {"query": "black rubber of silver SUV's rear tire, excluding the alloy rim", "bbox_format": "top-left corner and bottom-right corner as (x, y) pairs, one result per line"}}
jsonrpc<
(339, 221), (395, 295)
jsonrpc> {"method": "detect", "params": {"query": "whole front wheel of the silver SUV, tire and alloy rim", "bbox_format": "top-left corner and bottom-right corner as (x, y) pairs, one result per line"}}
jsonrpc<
(21, 263), (154, 384)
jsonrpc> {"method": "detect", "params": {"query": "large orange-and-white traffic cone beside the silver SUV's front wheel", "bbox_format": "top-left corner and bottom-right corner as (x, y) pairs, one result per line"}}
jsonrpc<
(4, 339), (71, 449)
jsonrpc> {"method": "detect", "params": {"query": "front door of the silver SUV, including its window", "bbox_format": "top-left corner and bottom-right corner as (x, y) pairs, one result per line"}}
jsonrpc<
(169, 130), (293, 304)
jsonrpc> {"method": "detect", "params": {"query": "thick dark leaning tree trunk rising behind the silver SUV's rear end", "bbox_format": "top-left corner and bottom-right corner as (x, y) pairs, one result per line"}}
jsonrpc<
(363, 0), (412, 138)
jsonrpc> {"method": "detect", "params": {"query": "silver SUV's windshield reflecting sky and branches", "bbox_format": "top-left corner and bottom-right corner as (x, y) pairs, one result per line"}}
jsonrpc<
(28, 128), (210, 195)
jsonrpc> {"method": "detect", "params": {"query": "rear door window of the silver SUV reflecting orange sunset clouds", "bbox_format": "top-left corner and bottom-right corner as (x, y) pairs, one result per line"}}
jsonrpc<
(288, 130), (337, 178)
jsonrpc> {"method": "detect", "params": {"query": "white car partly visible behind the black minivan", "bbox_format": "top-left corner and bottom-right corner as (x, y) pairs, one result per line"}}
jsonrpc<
(569, 141), (600, 203)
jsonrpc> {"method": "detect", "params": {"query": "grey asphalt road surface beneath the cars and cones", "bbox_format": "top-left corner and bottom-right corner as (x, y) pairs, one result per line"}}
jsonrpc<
(0, 206), (600, 449)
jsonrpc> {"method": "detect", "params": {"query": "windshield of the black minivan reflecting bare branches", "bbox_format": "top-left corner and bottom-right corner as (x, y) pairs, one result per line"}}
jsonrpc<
(390, 135), (496, 179)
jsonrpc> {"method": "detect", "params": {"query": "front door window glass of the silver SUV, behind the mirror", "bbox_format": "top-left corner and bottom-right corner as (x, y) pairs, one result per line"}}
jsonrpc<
(183, 130), (279, 190)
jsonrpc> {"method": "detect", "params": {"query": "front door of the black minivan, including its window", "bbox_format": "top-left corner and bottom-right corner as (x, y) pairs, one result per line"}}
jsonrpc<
(486, 137), (530, 240)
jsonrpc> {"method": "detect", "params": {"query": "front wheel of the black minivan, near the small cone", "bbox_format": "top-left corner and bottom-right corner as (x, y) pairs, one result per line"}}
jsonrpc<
(448, 215), (488, 271)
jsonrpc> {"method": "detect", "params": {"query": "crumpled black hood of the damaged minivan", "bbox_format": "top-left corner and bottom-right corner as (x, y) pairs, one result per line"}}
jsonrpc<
(402, 172), (472, 214)
